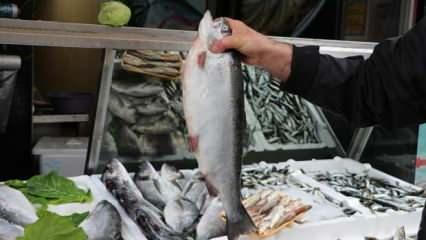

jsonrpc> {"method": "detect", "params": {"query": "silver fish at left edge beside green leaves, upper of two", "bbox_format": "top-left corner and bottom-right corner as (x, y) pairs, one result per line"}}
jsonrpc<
(0, 184), (37, 226)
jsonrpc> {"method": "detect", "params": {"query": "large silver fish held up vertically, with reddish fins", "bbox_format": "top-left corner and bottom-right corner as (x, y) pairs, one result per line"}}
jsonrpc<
(182, 12), (255, 240)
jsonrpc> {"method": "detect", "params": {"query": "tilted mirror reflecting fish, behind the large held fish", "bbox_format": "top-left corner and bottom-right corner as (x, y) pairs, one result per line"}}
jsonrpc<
(88, 47), (344, 172)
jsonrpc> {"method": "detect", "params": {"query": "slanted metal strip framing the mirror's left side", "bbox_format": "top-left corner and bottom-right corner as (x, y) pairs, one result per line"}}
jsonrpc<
(85, 49), (116, 174)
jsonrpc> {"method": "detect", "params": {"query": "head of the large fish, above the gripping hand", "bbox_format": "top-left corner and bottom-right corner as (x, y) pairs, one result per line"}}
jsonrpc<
(198, 11), (232, 49)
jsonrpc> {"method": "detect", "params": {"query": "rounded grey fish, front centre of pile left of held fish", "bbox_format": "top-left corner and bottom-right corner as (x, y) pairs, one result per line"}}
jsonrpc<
(164, 198), (200, 233)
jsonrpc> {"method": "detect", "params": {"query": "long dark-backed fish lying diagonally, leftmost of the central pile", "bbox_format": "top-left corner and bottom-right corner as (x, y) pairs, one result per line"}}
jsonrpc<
(102, 159), (180, 240)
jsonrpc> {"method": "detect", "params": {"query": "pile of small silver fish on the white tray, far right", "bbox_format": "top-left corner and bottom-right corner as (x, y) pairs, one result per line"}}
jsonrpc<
(310, 171), (426, 213)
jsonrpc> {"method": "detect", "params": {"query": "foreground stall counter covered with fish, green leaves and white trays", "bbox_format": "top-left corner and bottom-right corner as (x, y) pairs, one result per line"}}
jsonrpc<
(0, 158), (426, 240)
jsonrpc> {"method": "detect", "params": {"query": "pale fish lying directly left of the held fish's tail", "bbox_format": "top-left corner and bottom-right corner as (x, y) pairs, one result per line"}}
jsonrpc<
(196, 198), (226, 240)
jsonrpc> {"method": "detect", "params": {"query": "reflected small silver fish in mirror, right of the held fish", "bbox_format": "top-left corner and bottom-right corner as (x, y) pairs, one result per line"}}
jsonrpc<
(242, 65), (319, 144)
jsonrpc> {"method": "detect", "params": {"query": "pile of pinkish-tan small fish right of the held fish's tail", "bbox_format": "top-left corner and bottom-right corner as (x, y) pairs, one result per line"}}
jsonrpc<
(244, 190), (311, 236)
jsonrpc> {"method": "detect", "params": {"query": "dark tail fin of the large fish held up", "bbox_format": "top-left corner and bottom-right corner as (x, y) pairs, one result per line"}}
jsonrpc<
(226, 204), (256, 240)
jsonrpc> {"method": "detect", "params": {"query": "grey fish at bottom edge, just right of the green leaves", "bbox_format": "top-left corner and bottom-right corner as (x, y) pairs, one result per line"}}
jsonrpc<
(80, 200), (123, 240)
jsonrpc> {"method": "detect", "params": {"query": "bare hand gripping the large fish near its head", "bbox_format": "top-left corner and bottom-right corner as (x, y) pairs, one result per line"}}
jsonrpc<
(210, 18), (293, 82)
